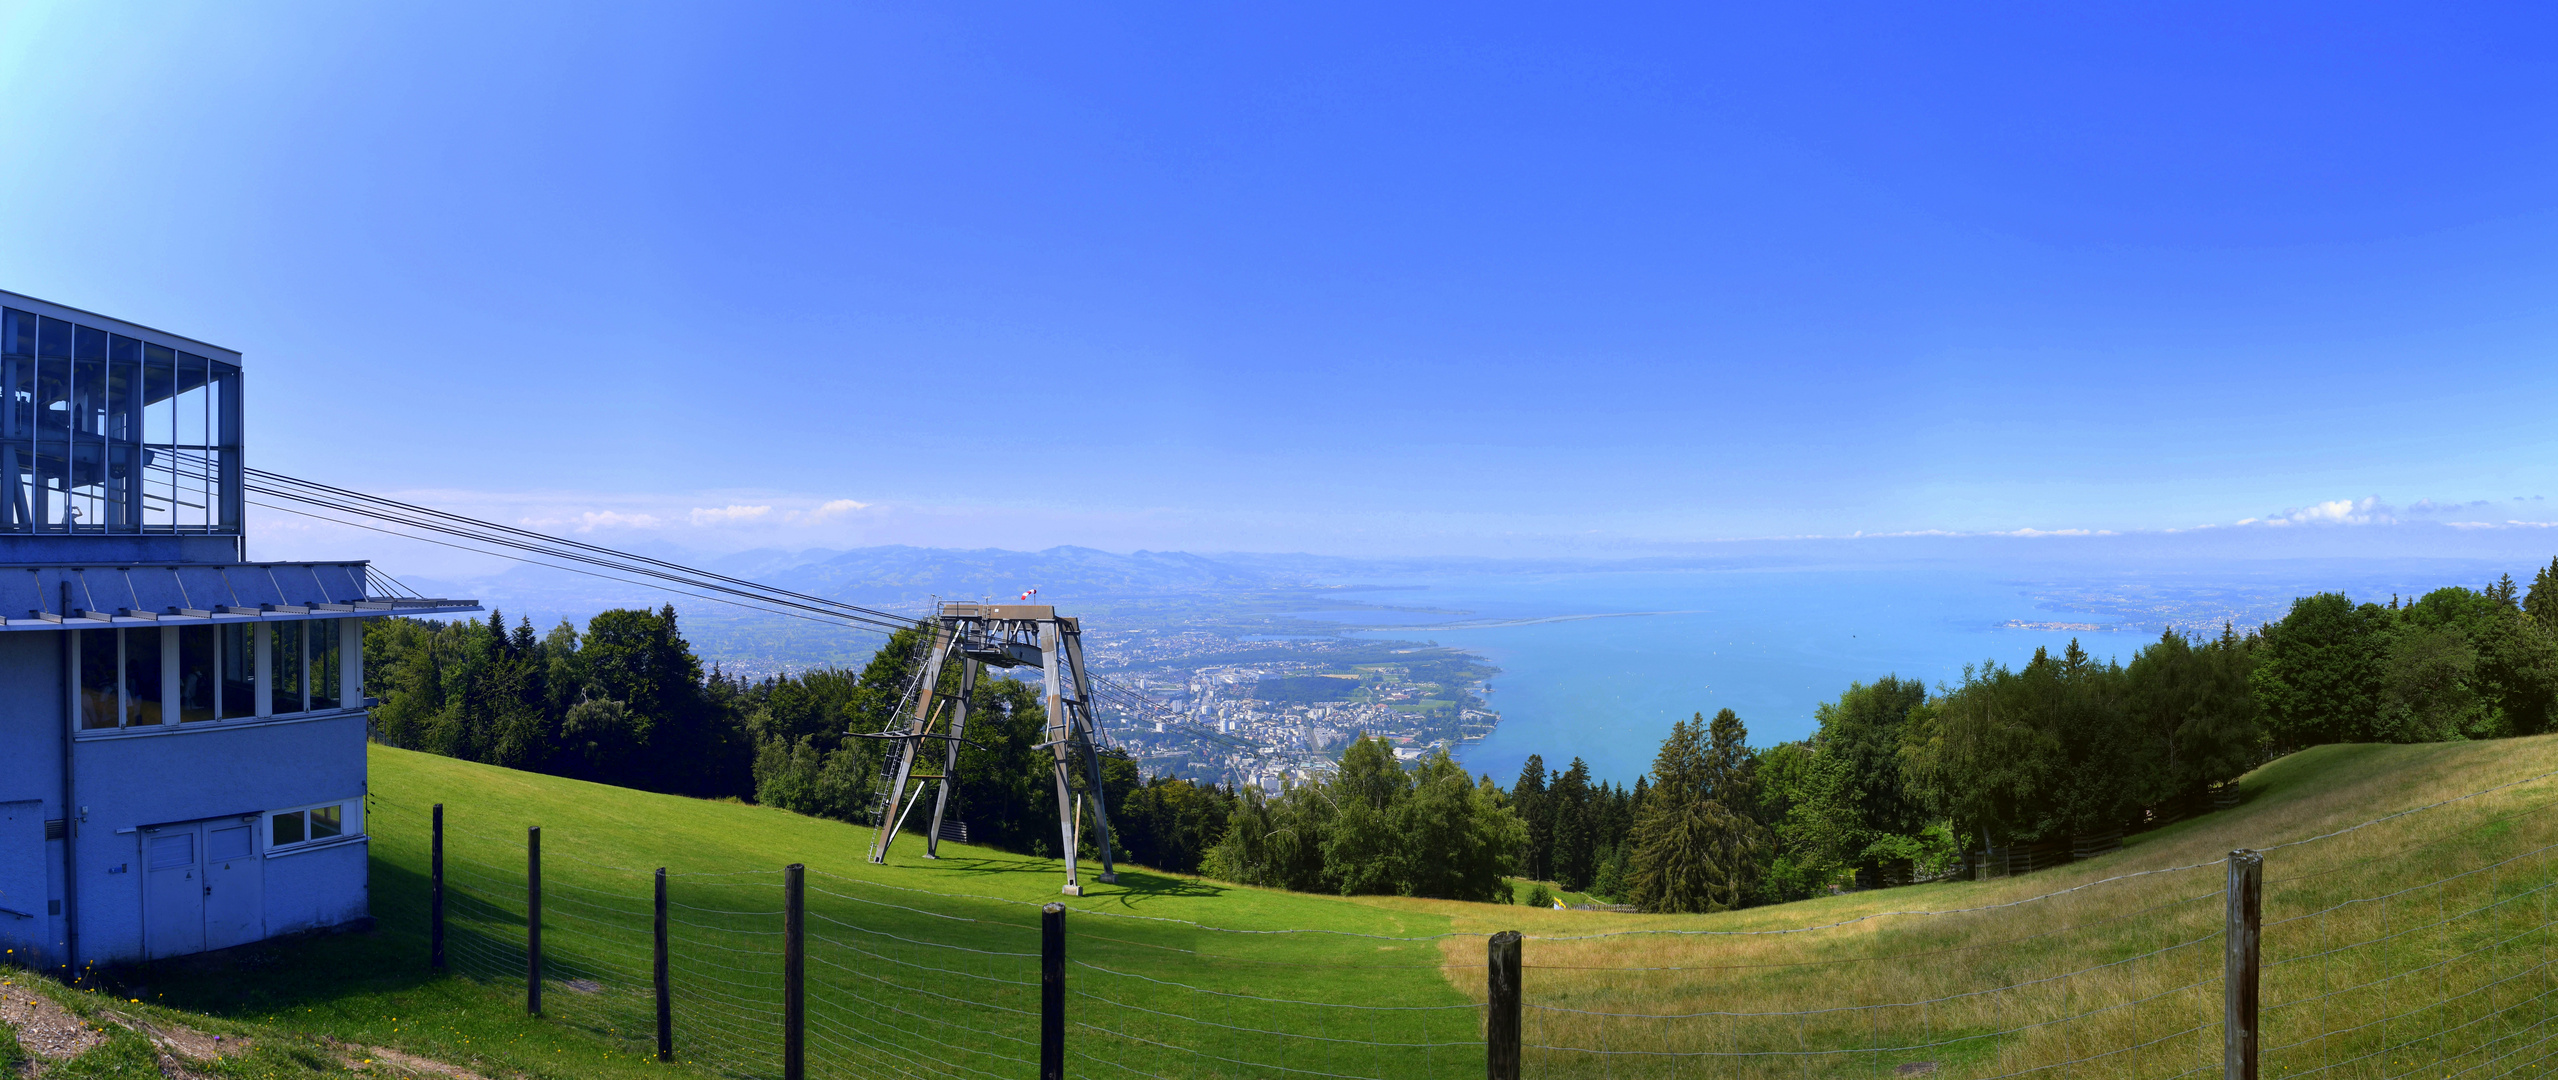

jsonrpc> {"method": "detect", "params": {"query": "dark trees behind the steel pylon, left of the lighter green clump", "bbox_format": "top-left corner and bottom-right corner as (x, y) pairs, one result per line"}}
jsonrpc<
(363, 607), (1236, 873)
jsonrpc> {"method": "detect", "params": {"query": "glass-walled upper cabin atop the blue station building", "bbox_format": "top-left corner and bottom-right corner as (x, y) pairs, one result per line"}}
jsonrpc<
(0, 307), (240, 535)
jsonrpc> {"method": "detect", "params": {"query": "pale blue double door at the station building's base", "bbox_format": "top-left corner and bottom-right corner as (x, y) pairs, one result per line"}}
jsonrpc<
(143, 814), (266, 960)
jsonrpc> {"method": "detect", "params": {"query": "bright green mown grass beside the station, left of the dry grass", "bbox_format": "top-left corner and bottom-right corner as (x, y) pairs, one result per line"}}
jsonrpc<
(368, 750), (1481, 1077)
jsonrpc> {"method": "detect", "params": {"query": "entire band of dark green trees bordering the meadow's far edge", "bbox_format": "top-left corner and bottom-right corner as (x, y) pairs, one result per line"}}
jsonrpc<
(366, 560), (2558, 911)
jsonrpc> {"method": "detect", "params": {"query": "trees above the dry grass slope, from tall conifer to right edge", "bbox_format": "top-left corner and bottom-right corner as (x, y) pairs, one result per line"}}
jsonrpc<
(1555, 560), (2558, 911)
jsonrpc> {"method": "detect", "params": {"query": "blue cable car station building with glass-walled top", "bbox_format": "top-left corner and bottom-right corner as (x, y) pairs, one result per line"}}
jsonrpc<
(0, 292), (478, 967)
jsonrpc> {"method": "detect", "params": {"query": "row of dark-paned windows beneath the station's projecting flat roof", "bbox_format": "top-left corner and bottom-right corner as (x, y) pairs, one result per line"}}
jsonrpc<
(72, 619), (363, 732)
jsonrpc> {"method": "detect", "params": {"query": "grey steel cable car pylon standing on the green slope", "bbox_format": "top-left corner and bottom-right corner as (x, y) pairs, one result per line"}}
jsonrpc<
(854, 604), (1118, 896)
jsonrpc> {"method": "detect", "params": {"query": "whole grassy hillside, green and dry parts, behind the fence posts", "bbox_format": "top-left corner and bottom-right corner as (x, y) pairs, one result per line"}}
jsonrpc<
(60, 737), (2558, 1080)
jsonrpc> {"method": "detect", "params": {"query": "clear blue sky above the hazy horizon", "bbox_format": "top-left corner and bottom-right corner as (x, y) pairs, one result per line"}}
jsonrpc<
(0, 3), (2558, 553)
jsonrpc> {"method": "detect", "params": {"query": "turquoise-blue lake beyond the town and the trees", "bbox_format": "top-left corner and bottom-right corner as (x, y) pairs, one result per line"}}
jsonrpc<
(1305, 560), (2517, 786)
